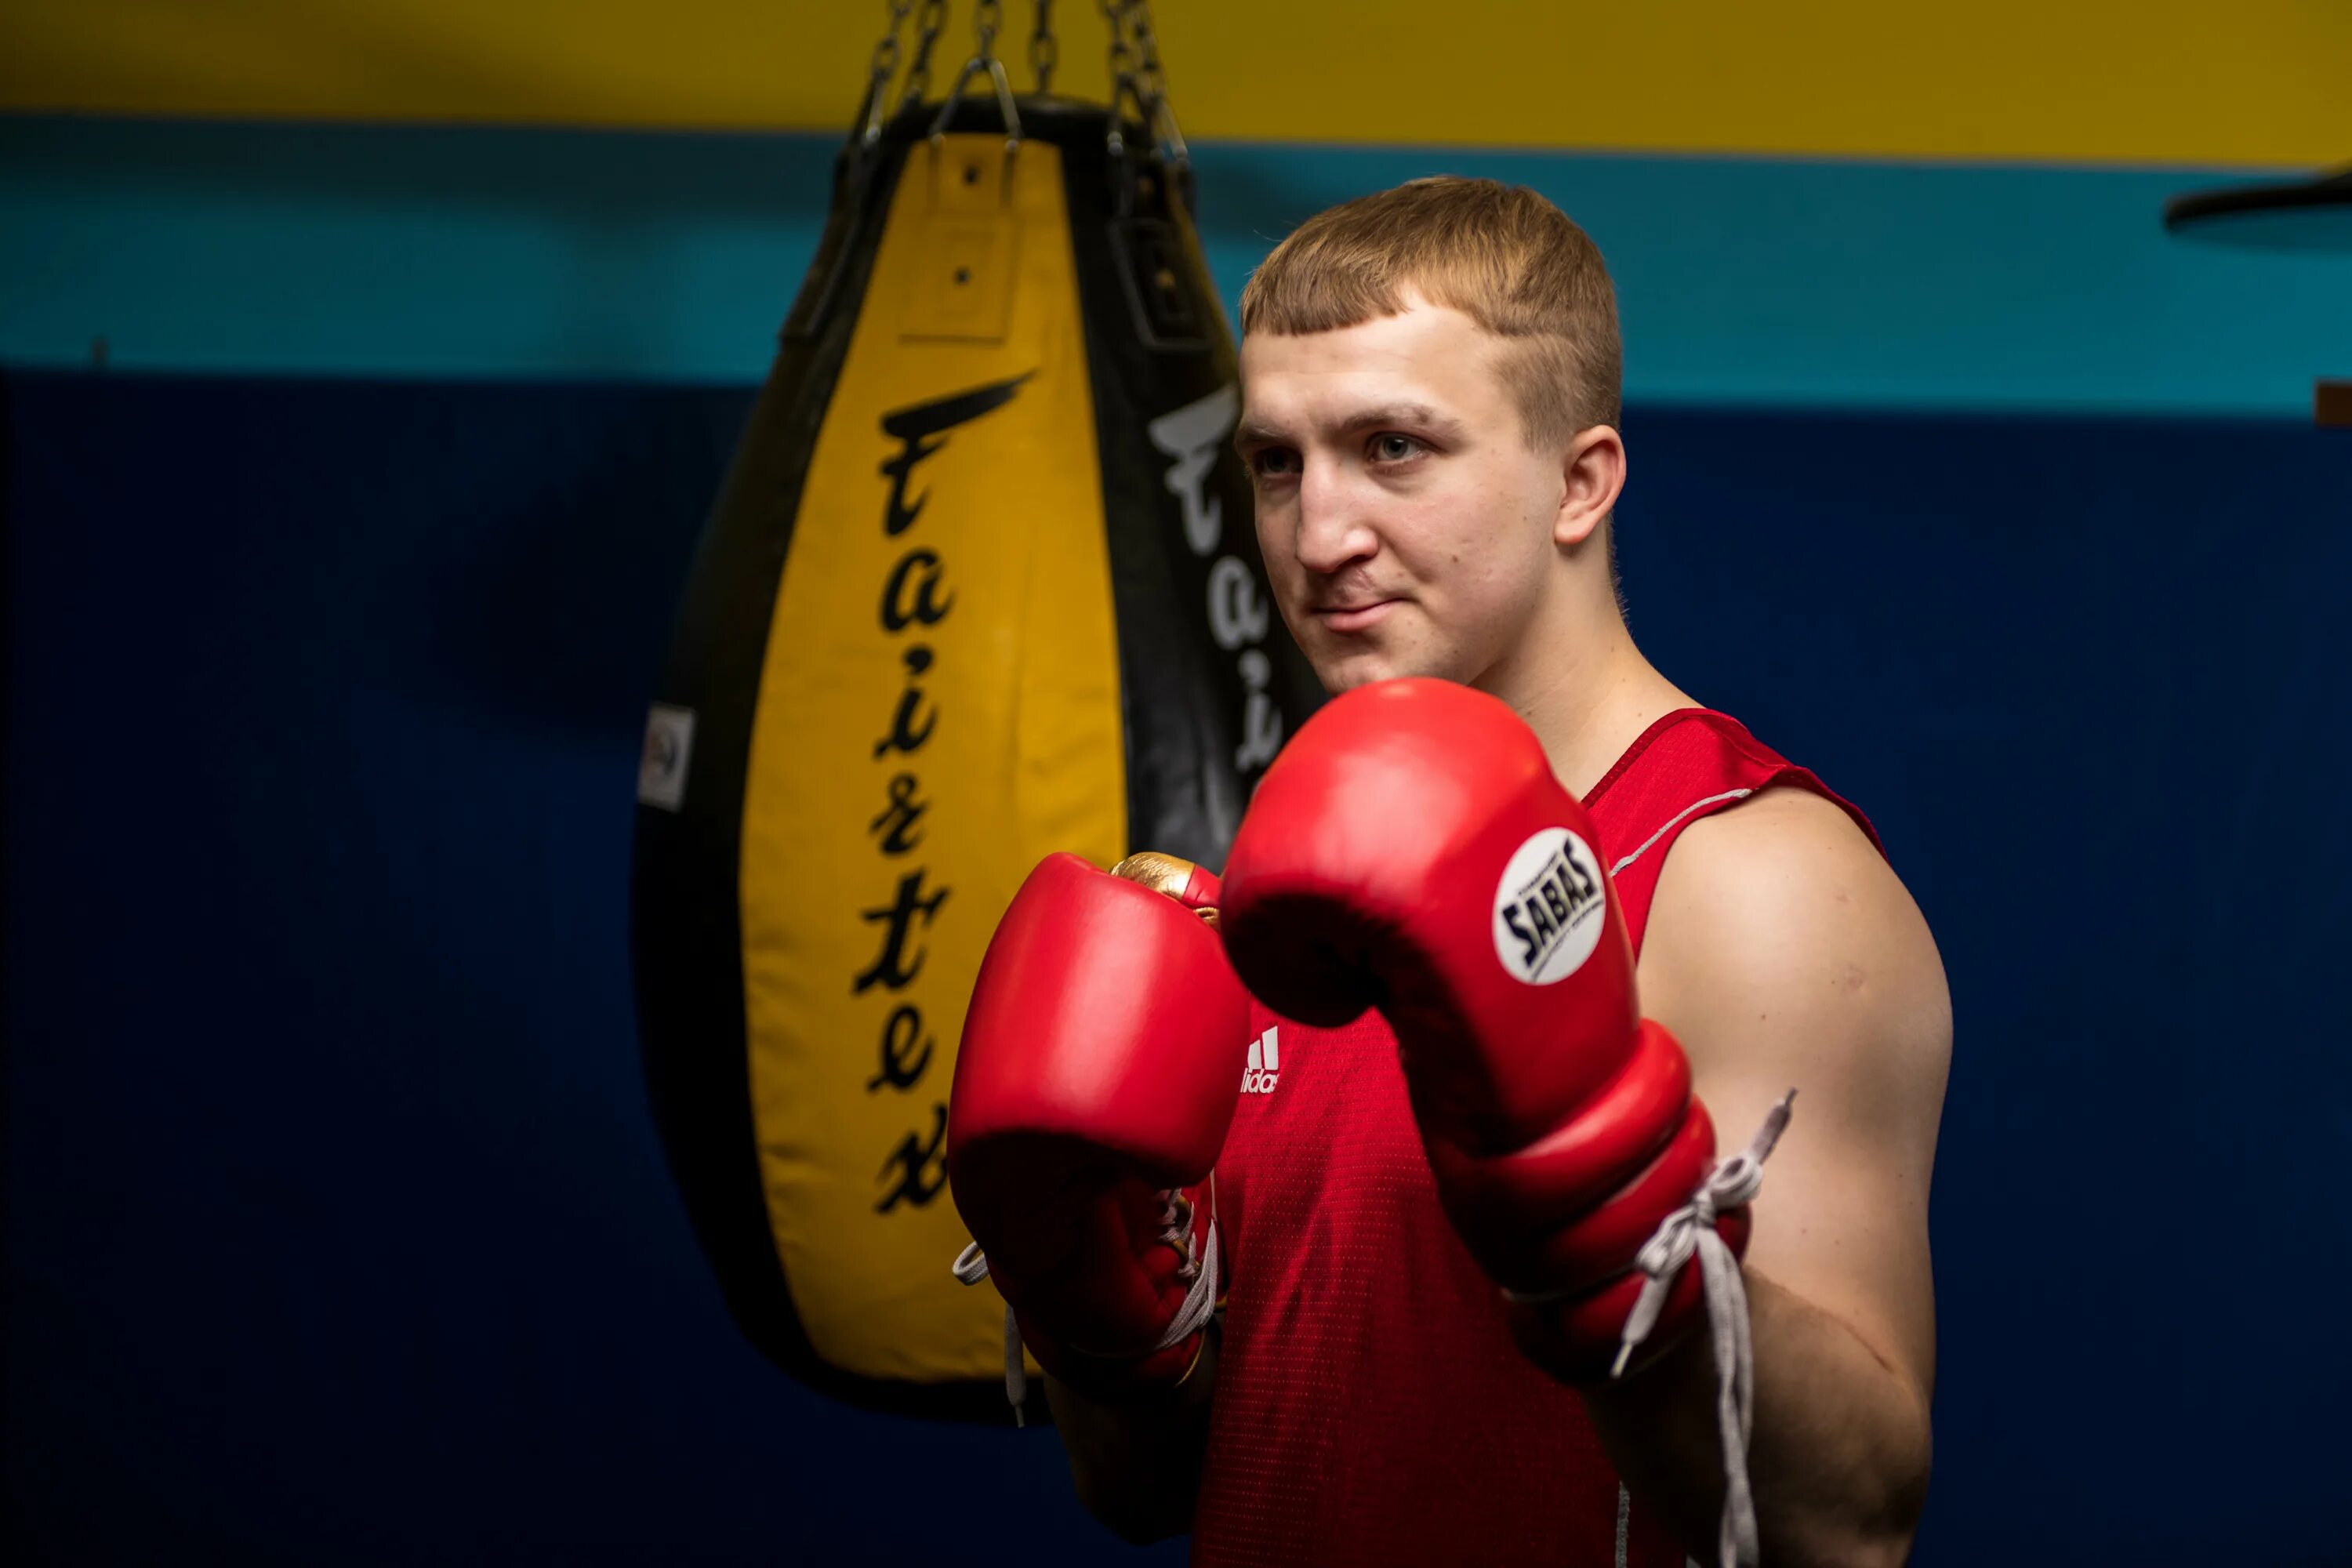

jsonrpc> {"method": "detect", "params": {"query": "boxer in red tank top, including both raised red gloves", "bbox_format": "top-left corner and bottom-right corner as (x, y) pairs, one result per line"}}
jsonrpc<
(948, 179), (1952, 1566)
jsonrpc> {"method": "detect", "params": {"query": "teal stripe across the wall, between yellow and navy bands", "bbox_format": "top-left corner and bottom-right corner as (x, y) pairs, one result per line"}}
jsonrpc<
(0, 118), (2352, 419)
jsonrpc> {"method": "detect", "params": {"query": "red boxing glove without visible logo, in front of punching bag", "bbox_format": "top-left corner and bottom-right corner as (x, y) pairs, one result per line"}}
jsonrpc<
(948, 853), (1249, 1406)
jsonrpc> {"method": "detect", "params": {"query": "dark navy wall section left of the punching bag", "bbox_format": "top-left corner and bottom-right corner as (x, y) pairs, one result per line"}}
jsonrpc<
(0, 374), (1138, 1563)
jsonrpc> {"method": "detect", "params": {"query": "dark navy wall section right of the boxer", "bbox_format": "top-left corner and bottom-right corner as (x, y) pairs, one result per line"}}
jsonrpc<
(1621, 409), (2352, 1566)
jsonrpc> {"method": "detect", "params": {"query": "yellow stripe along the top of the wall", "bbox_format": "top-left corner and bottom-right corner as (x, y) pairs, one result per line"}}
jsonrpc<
(0, 0), (2352, 165)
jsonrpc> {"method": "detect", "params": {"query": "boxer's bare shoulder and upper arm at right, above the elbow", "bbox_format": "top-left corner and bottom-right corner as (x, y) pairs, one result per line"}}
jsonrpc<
(1639, 789), (1952, 1389)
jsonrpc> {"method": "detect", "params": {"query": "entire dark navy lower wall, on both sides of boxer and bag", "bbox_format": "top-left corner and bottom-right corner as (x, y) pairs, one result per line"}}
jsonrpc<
(0, 374), (2352, 1566)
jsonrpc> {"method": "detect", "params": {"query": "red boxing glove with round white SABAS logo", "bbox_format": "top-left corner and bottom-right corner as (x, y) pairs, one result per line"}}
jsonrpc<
(1221, 680), (1748, 1382)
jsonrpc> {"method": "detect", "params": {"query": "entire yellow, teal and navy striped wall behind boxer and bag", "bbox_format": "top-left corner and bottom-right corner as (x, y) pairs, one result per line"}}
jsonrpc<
(0, 0), (2352, 1566)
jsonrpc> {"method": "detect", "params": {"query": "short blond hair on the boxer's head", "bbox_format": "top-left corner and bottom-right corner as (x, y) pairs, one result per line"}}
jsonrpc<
(1242, 174), (1625, 447)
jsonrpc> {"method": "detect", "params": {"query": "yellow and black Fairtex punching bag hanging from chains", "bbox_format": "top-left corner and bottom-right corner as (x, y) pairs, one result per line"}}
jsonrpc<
(635, 2), (1317, 1420)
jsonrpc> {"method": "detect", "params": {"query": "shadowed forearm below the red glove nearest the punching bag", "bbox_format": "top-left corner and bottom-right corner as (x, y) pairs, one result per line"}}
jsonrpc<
(1044, 1330), (1216, 1547)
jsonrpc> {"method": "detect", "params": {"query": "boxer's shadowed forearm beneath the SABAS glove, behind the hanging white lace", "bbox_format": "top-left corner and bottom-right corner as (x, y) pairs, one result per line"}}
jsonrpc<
(1585, 1269), (1929, 1568)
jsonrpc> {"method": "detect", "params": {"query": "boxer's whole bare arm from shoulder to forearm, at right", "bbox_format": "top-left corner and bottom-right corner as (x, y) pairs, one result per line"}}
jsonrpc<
(1588, 789), (1952, 1563)
